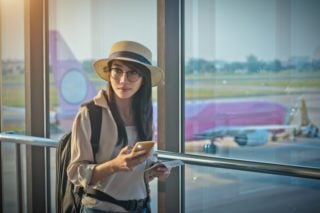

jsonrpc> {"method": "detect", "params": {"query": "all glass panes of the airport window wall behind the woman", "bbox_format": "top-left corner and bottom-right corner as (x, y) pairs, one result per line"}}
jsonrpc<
(0, 0), (320, 212)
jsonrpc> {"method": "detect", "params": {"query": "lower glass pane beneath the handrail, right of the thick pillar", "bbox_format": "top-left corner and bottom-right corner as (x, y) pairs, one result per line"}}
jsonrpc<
(185, 166), (320, 213)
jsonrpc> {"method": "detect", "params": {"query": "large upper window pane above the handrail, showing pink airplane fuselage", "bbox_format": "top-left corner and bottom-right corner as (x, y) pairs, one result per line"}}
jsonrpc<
(184, 0), (320, 167)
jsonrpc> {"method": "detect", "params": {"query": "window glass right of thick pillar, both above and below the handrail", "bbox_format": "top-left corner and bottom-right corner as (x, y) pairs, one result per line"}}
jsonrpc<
(183, 0), (320, 212)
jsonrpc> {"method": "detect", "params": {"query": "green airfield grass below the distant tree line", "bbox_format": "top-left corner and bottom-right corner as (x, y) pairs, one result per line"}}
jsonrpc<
(1, 71), (320, 106)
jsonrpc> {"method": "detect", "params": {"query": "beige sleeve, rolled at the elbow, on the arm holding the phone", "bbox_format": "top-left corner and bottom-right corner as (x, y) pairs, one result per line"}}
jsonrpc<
(67, 107), (96, 188)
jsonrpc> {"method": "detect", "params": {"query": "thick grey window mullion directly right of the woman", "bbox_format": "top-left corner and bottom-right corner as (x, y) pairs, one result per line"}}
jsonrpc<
(157, 0), (181, 213)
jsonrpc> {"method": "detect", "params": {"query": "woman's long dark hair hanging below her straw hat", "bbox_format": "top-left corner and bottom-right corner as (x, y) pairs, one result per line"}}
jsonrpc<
(105, 61), (153, 147)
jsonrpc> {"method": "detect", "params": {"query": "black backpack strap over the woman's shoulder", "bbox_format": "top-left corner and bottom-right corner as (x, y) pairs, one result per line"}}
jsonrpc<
(86, 101), (102, 162)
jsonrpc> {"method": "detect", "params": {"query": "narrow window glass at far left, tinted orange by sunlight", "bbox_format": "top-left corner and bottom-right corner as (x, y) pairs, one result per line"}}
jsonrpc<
(0, 0), (25, 212)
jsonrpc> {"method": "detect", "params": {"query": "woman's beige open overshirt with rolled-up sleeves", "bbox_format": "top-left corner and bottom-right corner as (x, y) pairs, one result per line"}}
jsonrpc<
(67, 90), (157, 210)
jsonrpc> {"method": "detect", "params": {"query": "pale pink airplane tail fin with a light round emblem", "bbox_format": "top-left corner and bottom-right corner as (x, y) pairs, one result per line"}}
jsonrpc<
(49, 30), (97, 127)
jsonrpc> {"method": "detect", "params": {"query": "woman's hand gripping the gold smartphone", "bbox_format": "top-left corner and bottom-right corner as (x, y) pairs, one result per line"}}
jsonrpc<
(112, 146), (150, 171)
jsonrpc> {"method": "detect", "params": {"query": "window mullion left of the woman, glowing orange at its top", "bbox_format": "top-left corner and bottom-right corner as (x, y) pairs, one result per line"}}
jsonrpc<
(25, 0), (48, 213)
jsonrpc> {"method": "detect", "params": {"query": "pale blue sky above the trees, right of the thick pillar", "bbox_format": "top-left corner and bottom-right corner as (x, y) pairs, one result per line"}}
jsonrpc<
(186, 0), (320, 61)
